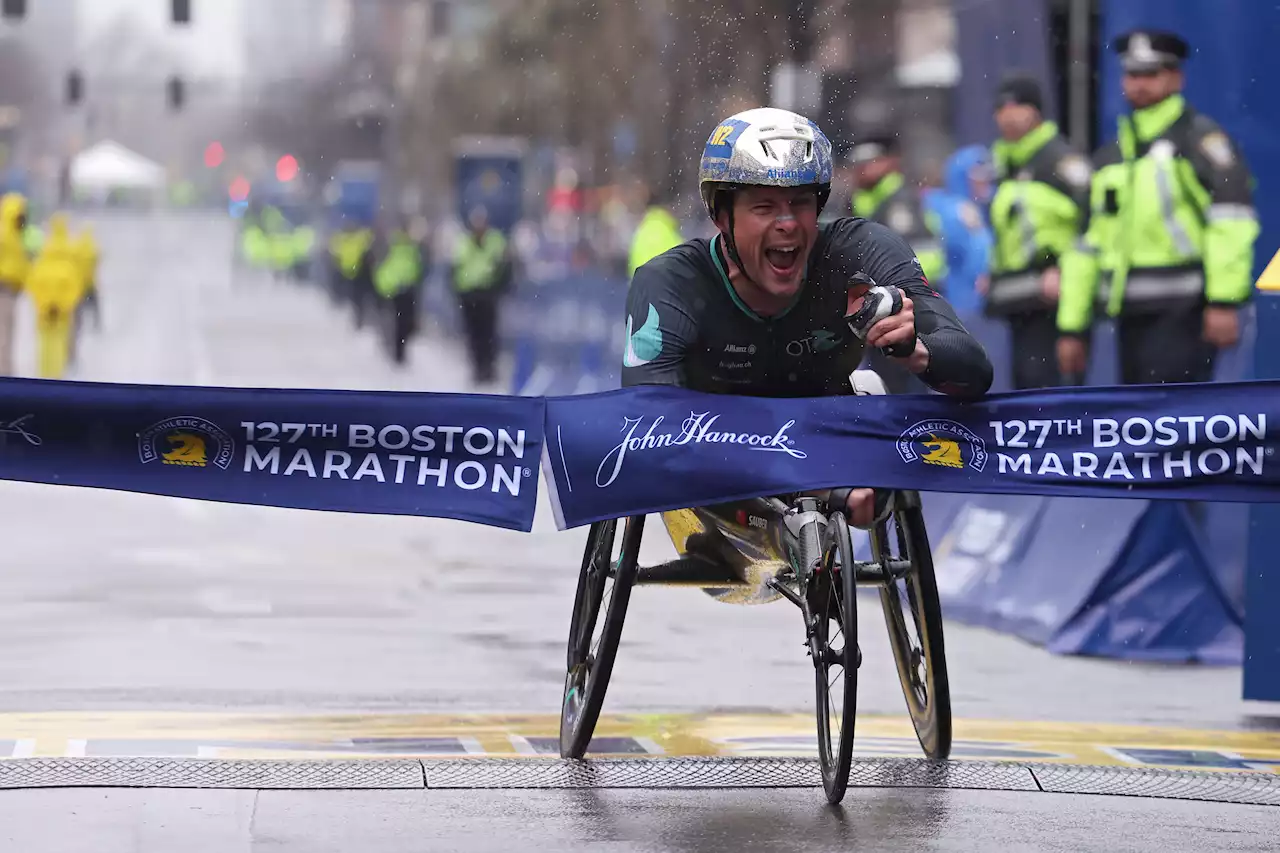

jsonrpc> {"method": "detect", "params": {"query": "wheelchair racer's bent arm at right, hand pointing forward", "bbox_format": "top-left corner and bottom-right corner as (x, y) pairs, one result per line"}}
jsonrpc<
(836, 222), (995, 398)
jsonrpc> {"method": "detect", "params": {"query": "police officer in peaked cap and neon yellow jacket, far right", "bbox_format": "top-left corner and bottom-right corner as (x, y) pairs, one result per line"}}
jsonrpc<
(1057, 29), (1258, 384)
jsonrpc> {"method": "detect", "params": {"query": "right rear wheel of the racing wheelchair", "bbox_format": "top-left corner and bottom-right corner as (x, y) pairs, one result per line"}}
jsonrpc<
(873, 498), (951, 760)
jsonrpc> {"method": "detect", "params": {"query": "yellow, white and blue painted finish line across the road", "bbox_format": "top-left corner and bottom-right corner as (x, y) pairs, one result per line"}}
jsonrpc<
(0, 712), (1280, 774)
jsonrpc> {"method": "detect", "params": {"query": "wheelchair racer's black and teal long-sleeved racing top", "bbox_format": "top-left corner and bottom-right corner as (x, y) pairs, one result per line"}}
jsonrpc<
(622, 216), (992, 400)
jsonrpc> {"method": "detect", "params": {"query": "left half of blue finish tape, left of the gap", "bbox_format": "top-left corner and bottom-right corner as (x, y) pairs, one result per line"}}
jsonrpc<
(0, 379), (545, 532)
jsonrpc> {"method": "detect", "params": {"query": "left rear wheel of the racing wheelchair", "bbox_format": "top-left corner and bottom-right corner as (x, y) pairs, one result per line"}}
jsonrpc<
(559, 515), (645, 758)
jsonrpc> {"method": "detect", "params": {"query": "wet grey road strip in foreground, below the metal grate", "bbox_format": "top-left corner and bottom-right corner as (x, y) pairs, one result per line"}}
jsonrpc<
(0, 789), (1276, 853)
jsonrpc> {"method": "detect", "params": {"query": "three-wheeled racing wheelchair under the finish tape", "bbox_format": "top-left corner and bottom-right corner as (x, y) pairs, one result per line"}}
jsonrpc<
(559, 370), (951, 804)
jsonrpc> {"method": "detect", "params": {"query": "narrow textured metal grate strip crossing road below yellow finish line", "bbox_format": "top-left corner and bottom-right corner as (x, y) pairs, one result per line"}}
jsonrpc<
(0, 757), (1280, 806)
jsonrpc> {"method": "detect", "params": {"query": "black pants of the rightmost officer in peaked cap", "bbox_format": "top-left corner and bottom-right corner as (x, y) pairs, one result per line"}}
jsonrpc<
(1117, 306), (1217, 386)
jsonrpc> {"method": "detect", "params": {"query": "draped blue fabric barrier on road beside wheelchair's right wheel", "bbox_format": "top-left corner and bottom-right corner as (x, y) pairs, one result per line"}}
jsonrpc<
(890, 493), (1243, 665)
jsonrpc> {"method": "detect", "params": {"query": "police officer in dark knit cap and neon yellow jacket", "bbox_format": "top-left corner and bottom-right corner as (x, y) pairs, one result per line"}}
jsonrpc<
(984, 73), (1093, 389)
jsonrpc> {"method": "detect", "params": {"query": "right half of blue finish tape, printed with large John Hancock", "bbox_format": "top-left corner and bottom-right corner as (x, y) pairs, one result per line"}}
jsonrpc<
(543, 382), (1280, 529)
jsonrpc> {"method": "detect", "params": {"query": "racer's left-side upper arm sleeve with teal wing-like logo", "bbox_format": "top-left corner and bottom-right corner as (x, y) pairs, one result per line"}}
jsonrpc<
(622, 259), (698, 388)
